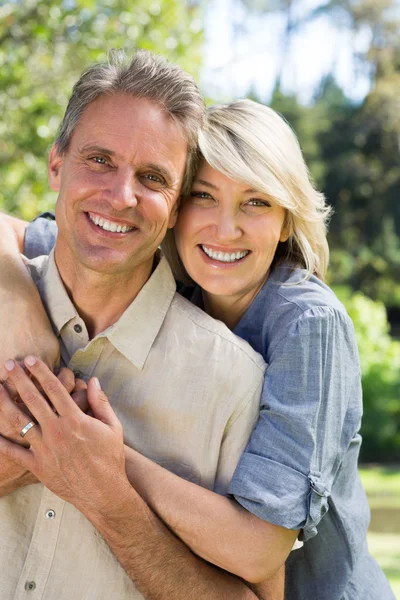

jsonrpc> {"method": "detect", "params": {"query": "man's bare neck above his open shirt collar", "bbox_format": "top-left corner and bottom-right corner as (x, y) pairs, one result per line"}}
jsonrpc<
(55, 247), (154, 339)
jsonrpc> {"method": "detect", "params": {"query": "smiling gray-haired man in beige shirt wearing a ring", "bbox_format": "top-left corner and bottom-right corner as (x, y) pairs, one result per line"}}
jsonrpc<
(0, 52), (290, 600)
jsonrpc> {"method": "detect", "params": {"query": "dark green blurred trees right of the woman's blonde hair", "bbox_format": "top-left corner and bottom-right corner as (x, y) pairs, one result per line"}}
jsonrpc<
(271, 71), (400, 307)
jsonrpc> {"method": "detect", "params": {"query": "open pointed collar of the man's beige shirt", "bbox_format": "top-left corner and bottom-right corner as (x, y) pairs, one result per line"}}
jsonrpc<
(39, 251), (176, 370)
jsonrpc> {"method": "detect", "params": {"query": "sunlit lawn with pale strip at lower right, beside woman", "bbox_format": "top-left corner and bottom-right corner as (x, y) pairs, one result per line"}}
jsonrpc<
(360, 466), (400, 600)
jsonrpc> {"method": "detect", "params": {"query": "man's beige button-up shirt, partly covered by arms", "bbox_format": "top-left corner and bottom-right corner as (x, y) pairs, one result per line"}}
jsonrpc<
(0, 254), (265, 600)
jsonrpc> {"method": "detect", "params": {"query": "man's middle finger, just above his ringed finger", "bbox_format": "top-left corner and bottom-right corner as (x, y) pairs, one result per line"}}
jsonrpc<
(5, 360), (56, 423)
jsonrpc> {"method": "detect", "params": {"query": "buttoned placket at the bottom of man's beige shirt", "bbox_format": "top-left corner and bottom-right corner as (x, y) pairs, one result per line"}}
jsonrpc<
(14, 488), (65, 600)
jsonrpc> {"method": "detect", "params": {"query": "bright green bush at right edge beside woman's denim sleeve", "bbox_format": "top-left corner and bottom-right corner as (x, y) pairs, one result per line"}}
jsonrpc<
(335, 287), (400, 462)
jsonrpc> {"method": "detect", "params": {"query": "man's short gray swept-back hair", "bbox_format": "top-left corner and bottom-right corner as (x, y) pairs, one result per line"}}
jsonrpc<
(55, 50), (205, 195)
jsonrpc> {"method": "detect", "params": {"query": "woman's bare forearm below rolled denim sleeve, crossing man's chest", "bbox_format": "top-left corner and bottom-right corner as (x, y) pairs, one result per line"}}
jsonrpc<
(125, 447), (297, 584)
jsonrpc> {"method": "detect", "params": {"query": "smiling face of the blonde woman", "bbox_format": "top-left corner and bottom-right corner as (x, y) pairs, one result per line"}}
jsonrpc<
(175, 162), (288, 299)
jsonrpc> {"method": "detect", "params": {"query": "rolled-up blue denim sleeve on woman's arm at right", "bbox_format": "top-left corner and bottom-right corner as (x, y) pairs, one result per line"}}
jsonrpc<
(229, 307), (362, 541)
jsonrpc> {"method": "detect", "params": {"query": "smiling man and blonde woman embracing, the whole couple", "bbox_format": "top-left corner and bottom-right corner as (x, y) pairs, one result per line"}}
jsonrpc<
(0, 51), (394, 600)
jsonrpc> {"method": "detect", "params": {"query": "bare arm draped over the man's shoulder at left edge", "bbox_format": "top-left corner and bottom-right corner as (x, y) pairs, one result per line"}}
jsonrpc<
(0, 215), (59, 379)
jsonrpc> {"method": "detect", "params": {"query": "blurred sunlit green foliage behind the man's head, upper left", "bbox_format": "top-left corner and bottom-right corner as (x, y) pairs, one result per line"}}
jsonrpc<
(0, 0), (203, 219)
